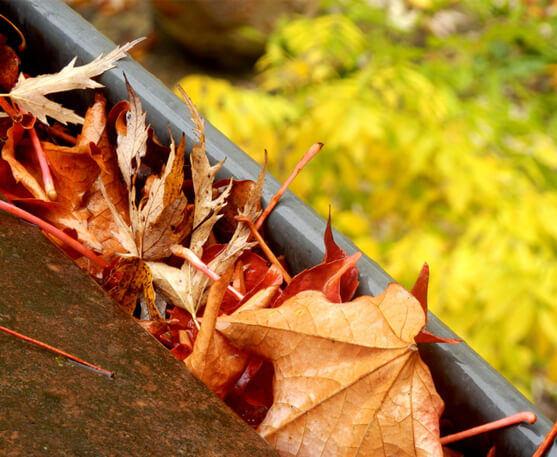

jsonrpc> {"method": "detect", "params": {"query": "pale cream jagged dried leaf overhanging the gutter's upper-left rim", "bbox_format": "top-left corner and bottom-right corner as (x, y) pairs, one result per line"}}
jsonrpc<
(7, 38), (143, 124)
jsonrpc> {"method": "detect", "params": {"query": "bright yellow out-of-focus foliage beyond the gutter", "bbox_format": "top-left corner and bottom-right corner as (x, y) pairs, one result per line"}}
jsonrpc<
(176, 10), (557, 393)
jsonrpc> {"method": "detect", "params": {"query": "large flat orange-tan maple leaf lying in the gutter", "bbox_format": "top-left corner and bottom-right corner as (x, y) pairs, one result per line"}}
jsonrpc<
(216, 284), (443, 457)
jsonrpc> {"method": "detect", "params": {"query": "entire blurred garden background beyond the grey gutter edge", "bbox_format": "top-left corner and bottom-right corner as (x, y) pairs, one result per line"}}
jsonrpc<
(67, 0), (557, 419)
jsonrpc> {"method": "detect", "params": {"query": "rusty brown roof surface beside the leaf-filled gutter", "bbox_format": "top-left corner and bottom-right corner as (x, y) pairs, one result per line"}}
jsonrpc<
(0, 214), (275, 457)
